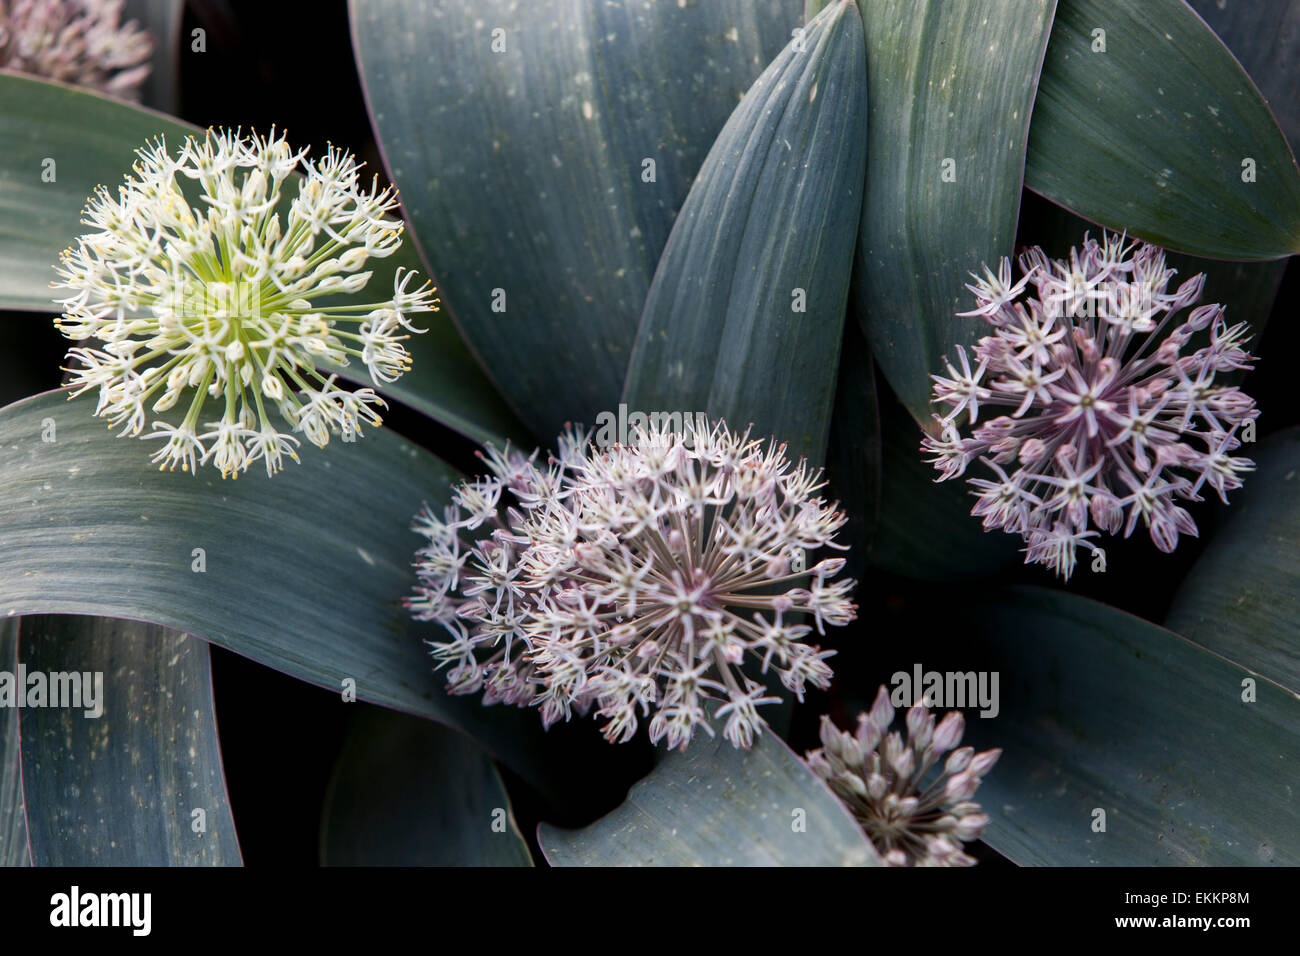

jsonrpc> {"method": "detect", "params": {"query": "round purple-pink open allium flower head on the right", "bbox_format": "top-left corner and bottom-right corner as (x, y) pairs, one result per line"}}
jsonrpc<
(922, 235), (1258, 579)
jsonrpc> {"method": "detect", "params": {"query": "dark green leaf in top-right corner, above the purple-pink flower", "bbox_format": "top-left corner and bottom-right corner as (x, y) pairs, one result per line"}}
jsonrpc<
(1024, 0), (1300, 259)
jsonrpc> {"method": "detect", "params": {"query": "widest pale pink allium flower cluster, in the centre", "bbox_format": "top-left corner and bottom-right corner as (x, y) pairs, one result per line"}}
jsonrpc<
(407, 421), (857, 748)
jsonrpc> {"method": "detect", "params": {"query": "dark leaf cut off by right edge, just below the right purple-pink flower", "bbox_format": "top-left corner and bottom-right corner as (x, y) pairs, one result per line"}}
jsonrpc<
(1166, 428), (1300, 691)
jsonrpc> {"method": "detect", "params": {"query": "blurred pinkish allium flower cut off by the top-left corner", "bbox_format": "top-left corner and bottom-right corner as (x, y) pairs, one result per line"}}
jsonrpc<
(0, 0), (153, 100)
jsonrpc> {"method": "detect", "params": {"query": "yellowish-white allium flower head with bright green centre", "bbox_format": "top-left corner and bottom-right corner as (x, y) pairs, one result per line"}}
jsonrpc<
(56, 130), (437, 477)
